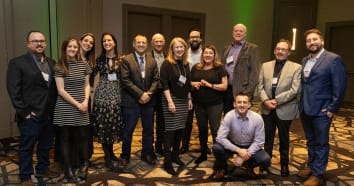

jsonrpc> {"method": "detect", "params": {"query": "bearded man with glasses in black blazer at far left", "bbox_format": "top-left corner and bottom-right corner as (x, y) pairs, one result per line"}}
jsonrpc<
(7, 31), (59, 185)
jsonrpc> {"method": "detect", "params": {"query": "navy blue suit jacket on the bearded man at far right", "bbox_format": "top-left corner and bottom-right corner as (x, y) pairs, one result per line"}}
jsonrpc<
(299, 50), (347, 116)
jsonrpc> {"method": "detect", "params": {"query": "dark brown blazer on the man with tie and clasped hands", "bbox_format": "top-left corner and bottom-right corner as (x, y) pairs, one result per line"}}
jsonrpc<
(121, 53), (159, 107)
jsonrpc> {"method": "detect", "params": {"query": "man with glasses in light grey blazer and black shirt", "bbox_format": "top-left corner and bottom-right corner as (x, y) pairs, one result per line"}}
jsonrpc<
(258, 39), (301, 177)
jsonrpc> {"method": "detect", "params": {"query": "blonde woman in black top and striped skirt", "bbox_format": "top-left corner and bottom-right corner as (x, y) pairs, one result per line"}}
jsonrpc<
(160, 37), (193, 175)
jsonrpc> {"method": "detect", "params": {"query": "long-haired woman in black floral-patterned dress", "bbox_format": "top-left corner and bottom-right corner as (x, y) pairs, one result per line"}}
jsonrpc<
(92, 33), (123, 171)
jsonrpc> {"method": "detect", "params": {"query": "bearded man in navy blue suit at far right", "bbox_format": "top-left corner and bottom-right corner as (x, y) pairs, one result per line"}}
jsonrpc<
(297, 29), (346, 185)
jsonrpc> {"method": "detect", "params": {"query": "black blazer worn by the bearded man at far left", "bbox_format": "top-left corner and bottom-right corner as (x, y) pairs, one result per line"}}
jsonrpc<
(7, 52), (57, 122)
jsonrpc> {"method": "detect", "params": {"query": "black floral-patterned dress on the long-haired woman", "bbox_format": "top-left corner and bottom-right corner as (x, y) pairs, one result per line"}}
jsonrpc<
(92, 56), (123, 144)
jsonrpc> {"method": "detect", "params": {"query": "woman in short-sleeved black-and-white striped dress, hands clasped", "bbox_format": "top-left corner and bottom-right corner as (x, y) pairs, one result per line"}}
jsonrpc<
(54, 38), (91, 183)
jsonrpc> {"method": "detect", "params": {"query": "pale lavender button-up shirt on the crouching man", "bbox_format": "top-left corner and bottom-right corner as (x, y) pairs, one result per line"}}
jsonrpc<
(216, 109), (264, 155)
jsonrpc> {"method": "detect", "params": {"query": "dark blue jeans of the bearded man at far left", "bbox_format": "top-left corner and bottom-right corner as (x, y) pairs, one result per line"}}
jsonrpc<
(18, 119), (54, 181)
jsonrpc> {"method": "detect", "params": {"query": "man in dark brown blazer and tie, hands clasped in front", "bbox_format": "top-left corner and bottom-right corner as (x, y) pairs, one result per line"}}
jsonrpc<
(121, 35), (159, 165)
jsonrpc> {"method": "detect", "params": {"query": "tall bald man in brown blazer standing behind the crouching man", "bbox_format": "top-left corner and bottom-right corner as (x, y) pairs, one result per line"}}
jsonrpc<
(221, 24), (260, 114)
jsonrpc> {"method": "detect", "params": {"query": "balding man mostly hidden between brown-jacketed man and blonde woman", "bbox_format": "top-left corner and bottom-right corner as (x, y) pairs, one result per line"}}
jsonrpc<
(151, 33), (165, 156)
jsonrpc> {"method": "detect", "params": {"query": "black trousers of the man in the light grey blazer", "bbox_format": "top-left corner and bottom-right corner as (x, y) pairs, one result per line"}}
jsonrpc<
(262, 110), (292, 165)
